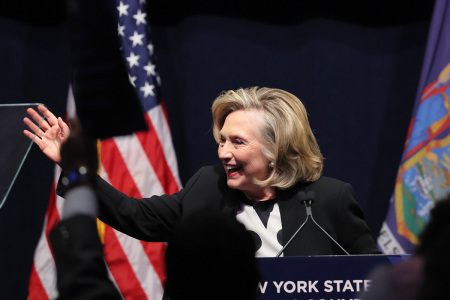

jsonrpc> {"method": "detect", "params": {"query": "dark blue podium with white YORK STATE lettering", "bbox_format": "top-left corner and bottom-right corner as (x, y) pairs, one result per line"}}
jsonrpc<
(257, 255), (411, 300)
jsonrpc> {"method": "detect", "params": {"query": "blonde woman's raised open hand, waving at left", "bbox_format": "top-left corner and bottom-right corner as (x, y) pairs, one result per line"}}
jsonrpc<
(23, 105), (70, 163)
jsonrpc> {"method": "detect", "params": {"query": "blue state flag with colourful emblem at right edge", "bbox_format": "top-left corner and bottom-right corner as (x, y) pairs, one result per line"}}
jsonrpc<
(378, 0), (450, 254)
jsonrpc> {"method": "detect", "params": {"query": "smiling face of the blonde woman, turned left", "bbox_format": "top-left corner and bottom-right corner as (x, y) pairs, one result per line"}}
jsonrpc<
(218, 110), (269, 199)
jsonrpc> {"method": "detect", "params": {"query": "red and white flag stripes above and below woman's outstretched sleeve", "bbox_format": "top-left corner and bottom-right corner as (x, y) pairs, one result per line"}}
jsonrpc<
(100, 105), (181, 299)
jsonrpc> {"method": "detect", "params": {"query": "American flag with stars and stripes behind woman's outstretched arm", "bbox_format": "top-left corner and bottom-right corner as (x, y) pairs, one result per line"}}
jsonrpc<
(29, 0), (181, 300)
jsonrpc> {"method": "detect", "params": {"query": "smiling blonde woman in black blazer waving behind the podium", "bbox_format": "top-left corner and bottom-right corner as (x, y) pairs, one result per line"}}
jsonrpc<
(24, 87), (379, 256)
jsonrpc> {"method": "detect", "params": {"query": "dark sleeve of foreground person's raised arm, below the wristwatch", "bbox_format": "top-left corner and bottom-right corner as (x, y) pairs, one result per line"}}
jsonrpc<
(50, 215), (122, 300)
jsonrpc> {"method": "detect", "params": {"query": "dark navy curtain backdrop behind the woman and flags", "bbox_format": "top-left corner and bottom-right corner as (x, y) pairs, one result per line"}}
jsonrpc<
(0, 1), (433, 299)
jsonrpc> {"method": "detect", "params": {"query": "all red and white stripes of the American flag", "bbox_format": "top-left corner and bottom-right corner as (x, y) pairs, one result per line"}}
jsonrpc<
(29, 98), (181, 300)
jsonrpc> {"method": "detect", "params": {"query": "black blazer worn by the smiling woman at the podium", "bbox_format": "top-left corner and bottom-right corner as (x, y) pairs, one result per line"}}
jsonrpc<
(92, 166), (380, 256)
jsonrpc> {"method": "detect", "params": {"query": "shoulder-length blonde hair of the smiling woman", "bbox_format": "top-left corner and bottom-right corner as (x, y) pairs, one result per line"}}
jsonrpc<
(212, 87), (323, 189)
